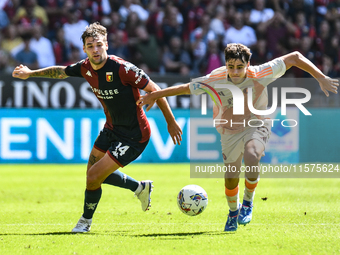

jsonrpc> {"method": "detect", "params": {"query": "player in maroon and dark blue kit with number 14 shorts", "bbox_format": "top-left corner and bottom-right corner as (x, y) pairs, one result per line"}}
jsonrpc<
(12, 22), (182, 232)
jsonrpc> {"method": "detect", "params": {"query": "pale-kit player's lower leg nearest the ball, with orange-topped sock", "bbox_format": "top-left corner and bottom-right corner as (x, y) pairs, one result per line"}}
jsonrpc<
(224, 154), (243, 231)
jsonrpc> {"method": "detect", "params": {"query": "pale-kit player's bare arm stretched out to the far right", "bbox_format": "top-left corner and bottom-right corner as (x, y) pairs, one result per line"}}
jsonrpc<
(281, 51), (339, 96)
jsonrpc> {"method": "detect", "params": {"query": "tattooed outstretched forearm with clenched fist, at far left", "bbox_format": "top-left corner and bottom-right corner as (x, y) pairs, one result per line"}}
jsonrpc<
(12, 65), (68, 80)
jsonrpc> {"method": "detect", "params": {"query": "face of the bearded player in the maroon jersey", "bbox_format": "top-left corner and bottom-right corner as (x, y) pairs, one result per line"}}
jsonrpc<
(83, 35), (108, 70)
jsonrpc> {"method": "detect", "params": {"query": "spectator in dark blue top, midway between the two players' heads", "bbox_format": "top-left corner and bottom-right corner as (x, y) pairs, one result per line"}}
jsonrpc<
(163, 36), (191, 75)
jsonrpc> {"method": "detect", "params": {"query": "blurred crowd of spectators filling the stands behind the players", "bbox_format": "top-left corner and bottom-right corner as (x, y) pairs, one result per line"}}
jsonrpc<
(0, 0), (340, 77)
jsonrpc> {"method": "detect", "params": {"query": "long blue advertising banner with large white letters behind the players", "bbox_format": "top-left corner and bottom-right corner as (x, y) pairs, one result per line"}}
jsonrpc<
(0, 108), (340, 164)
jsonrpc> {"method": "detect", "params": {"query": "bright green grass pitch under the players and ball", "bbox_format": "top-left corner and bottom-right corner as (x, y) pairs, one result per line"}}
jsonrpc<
(0, 164), (340, 255)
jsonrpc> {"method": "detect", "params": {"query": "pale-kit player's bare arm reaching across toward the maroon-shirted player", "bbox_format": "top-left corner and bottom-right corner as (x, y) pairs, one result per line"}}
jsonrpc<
(136, 83), (190, 111)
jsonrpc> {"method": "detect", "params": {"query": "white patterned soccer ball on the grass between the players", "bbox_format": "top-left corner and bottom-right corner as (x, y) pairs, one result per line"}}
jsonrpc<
(177, 185), (208, 216)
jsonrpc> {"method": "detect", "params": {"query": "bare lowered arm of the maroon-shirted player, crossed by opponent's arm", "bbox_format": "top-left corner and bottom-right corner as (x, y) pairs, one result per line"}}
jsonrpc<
(144, 80), (183, 145)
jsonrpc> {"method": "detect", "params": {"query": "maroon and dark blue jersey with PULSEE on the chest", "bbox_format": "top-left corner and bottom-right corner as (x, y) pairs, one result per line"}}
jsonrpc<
(65, 55), (151, 143)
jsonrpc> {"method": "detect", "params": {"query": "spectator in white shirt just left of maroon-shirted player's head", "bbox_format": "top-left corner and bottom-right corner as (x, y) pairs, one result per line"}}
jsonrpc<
(63, 8), (89, 58)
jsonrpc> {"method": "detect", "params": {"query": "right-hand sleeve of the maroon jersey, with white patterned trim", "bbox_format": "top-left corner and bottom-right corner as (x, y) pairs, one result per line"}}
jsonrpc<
(119, 62), (150, 89)
